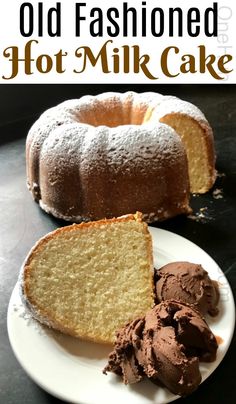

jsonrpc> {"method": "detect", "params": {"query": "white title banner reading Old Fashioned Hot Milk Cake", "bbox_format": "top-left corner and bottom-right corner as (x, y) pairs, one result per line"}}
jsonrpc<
(0, 0), (236, 84)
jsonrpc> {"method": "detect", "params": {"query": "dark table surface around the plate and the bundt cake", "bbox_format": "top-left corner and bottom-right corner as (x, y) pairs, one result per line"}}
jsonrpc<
(0, 85), (236, 404)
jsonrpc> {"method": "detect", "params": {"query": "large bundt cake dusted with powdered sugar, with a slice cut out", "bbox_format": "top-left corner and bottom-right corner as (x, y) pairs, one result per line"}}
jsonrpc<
(26, 92), (215, 222)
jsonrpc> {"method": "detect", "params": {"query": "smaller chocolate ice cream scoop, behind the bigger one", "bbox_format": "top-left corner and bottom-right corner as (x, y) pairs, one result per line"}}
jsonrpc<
(155, 262), (219, 316)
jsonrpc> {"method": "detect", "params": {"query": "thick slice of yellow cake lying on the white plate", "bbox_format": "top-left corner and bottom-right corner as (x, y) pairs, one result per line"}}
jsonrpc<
(20, 213), (154, 343)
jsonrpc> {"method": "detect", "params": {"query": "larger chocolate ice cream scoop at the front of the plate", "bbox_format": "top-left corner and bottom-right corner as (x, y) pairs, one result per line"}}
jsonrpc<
(104, 300), (217, 396)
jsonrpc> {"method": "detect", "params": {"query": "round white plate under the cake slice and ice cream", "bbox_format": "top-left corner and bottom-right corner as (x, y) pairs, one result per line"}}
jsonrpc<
(8, 227), (235, 404)
